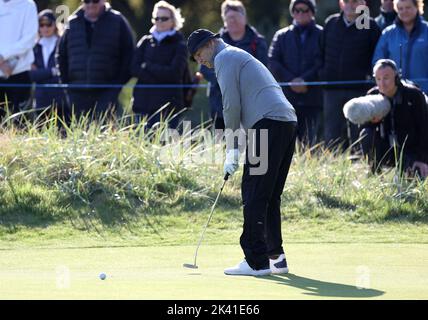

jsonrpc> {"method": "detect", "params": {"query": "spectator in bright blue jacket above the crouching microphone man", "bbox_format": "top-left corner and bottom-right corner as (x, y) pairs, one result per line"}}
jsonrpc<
(373, 0), (428, 93)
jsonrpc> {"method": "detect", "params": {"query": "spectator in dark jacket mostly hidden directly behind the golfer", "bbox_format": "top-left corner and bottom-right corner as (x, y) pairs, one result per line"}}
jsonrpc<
(201, 0), (268, 129)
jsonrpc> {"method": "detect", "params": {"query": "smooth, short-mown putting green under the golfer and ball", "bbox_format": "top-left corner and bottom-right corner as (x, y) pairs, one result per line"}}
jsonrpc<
(0, 243), (428, 300)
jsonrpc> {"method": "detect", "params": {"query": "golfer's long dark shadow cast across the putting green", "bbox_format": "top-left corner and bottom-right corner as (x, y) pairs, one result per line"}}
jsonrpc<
(261, 274), (385, 298)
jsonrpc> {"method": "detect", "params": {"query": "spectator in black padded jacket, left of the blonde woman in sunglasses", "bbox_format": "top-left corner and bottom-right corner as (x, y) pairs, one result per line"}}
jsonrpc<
(57, 0), (135, 117)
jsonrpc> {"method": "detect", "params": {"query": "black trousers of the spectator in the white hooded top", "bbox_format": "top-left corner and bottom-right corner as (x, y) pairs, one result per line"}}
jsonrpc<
(0, 71), (31, 119)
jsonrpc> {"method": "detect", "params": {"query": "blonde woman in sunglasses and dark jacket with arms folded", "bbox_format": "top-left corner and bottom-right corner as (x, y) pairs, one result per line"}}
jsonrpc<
(131, 1), (188, 128)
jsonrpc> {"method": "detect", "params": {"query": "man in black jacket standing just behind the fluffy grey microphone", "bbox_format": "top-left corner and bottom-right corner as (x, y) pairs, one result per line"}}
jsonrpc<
(320, 0), (380, 147)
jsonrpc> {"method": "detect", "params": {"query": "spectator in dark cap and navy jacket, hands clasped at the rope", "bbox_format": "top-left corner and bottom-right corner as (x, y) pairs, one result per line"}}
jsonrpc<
(269, 0), (322, 146)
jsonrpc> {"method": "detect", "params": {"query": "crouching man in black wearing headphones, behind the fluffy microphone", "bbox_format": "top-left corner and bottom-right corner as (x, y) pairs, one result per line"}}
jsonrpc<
(361, 59), (428, 178)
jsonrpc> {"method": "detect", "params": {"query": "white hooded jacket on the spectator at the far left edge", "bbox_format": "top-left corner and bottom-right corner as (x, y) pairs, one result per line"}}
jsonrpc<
(0, 0), (39, 77)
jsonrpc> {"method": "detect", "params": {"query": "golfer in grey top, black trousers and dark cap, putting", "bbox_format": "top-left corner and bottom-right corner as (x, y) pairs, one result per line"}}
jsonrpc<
(188, 29), (297, 276)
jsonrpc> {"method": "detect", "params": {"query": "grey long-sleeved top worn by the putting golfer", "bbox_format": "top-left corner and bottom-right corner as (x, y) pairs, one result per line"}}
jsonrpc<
(214, 45), (297, 131)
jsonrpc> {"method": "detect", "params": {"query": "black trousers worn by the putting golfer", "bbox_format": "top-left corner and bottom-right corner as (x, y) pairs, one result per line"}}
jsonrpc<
(240, 119), (297, 270)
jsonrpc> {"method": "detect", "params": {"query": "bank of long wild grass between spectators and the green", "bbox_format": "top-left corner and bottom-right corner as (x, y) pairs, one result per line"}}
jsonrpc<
(0, 118), (428, 247)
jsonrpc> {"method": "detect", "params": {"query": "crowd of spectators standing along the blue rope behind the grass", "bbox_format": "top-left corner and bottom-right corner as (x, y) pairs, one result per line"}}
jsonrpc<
(0, 0), (428, 175)
